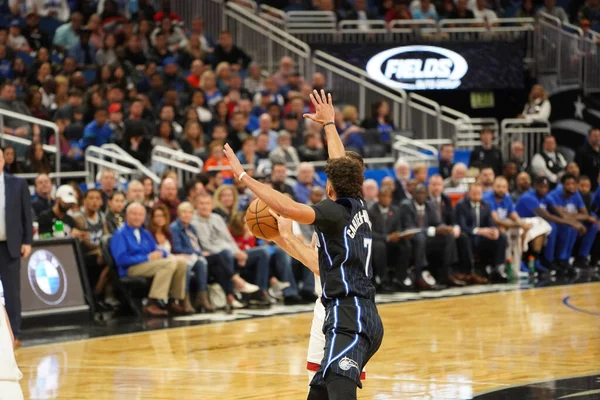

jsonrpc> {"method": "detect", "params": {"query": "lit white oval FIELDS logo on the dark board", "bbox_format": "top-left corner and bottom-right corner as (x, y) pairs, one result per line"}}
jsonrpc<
(367, 46), (468, 90)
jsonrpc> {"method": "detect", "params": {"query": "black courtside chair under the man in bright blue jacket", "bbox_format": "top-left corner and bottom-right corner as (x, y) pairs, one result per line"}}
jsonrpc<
(102, 236), (152, 317)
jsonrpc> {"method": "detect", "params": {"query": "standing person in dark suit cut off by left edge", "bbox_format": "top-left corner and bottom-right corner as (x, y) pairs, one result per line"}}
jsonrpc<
(0, 149), (33, 347)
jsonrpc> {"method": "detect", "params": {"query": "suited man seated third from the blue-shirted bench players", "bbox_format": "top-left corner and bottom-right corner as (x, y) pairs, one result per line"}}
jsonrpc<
(400, 184), (465, 290)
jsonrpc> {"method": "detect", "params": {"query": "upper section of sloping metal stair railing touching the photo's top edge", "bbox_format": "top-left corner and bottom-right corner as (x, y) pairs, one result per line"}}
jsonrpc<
(225, 2), (310, 79)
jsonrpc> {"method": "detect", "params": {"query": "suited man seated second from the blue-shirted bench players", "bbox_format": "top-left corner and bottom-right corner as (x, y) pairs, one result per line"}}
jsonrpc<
(427, 175), (487, 284)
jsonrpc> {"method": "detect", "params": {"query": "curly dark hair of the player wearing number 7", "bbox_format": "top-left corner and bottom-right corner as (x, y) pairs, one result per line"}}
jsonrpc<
(325, 157), (365, 199)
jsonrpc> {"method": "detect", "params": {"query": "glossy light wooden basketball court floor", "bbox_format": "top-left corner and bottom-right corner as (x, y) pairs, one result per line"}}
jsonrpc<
(17, 282), (600, 400)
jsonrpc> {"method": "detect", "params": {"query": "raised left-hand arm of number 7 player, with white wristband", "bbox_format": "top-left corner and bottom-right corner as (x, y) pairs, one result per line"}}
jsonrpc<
(223, 144), (316, 224)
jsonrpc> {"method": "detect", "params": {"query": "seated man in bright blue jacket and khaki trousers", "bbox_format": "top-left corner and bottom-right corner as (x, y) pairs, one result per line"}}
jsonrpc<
(110, 203), (187, 317)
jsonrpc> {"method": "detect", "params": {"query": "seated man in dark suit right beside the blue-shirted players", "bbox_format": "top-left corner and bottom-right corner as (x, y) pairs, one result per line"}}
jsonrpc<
(454, 183), (507, 283)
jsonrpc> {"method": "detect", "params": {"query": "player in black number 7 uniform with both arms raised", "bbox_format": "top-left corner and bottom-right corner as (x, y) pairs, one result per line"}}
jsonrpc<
(224, 90), (383, 400)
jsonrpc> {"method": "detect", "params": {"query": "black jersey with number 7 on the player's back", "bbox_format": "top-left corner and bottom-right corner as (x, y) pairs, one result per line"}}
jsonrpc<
(312, 198), (375, 305)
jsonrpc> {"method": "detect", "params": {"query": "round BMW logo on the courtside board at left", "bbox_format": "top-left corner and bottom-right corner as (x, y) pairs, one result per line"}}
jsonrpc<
(27, 250), (67, 306)
